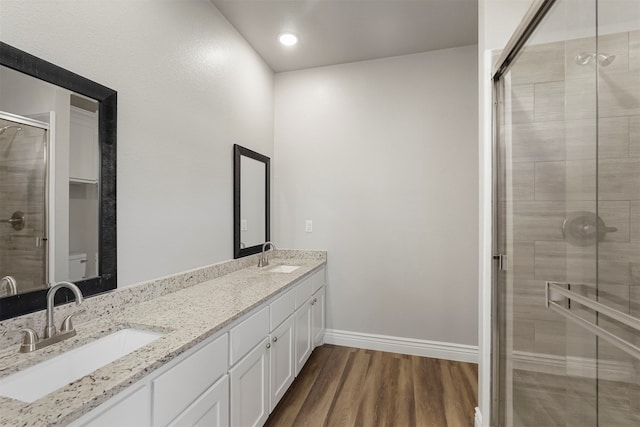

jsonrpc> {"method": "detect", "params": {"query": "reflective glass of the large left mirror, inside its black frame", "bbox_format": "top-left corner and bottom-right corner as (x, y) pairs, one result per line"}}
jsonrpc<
(0, 67), (100, 297)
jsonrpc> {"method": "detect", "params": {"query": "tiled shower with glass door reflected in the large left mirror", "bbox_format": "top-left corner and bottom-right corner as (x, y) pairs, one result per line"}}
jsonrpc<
(0, 113), (47, 297)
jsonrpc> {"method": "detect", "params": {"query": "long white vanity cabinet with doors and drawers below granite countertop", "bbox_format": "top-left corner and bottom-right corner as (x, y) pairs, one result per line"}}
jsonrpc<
(72, 268), (325, 427)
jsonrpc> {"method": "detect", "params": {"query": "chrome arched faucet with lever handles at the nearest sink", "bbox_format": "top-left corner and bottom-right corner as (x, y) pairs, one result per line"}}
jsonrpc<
(3, 282), (84, 353)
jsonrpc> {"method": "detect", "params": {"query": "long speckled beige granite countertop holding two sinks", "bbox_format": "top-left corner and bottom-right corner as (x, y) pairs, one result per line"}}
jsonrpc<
(0, 258), (326, 426)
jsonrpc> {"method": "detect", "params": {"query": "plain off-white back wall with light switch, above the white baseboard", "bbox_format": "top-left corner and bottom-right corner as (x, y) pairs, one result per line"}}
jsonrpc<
(272, 46), (478, 345)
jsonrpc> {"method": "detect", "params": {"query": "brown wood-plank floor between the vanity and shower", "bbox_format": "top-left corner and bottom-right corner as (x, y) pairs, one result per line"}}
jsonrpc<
(265, 344), (478, 427)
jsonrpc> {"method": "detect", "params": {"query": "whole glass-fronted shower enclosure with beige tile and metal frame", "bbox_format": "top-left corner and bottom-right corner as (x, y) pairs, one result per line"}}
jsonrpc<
(491, 0), (640, 426)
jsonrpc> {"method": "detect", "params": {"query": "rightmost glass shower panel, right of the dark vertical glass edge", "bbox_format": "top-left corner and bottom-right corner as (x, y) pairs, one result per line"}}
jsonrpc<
(590, 0), (640, 426)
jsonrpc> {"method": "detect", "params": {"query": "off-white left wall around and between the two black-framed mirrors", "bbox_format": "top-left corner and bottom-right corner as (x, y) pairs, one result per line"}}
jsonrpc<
(0, 0), (273, 286)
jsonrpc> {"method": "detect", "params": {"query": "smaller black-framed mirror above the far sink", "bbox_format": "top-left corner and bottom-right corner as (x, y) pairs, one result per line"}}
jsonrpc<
(233, 144), (270, 258)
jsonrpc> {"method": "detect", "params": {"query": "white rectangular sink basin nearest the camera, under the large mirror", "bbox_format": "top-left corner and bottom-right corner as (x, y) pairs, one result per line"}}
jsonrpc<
(0, 329), (164, 403)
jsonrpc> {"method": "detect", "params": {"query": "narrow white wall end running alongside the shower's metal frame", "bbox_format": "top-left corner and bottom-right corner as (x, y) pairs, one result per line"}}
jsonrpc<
(477, 0), (533, 426)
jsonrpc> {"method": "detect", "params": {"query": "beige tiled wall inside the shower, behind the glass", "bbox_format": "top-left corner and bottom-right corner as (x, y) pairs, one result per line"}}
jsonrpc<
(505, 31), (640, 359)
